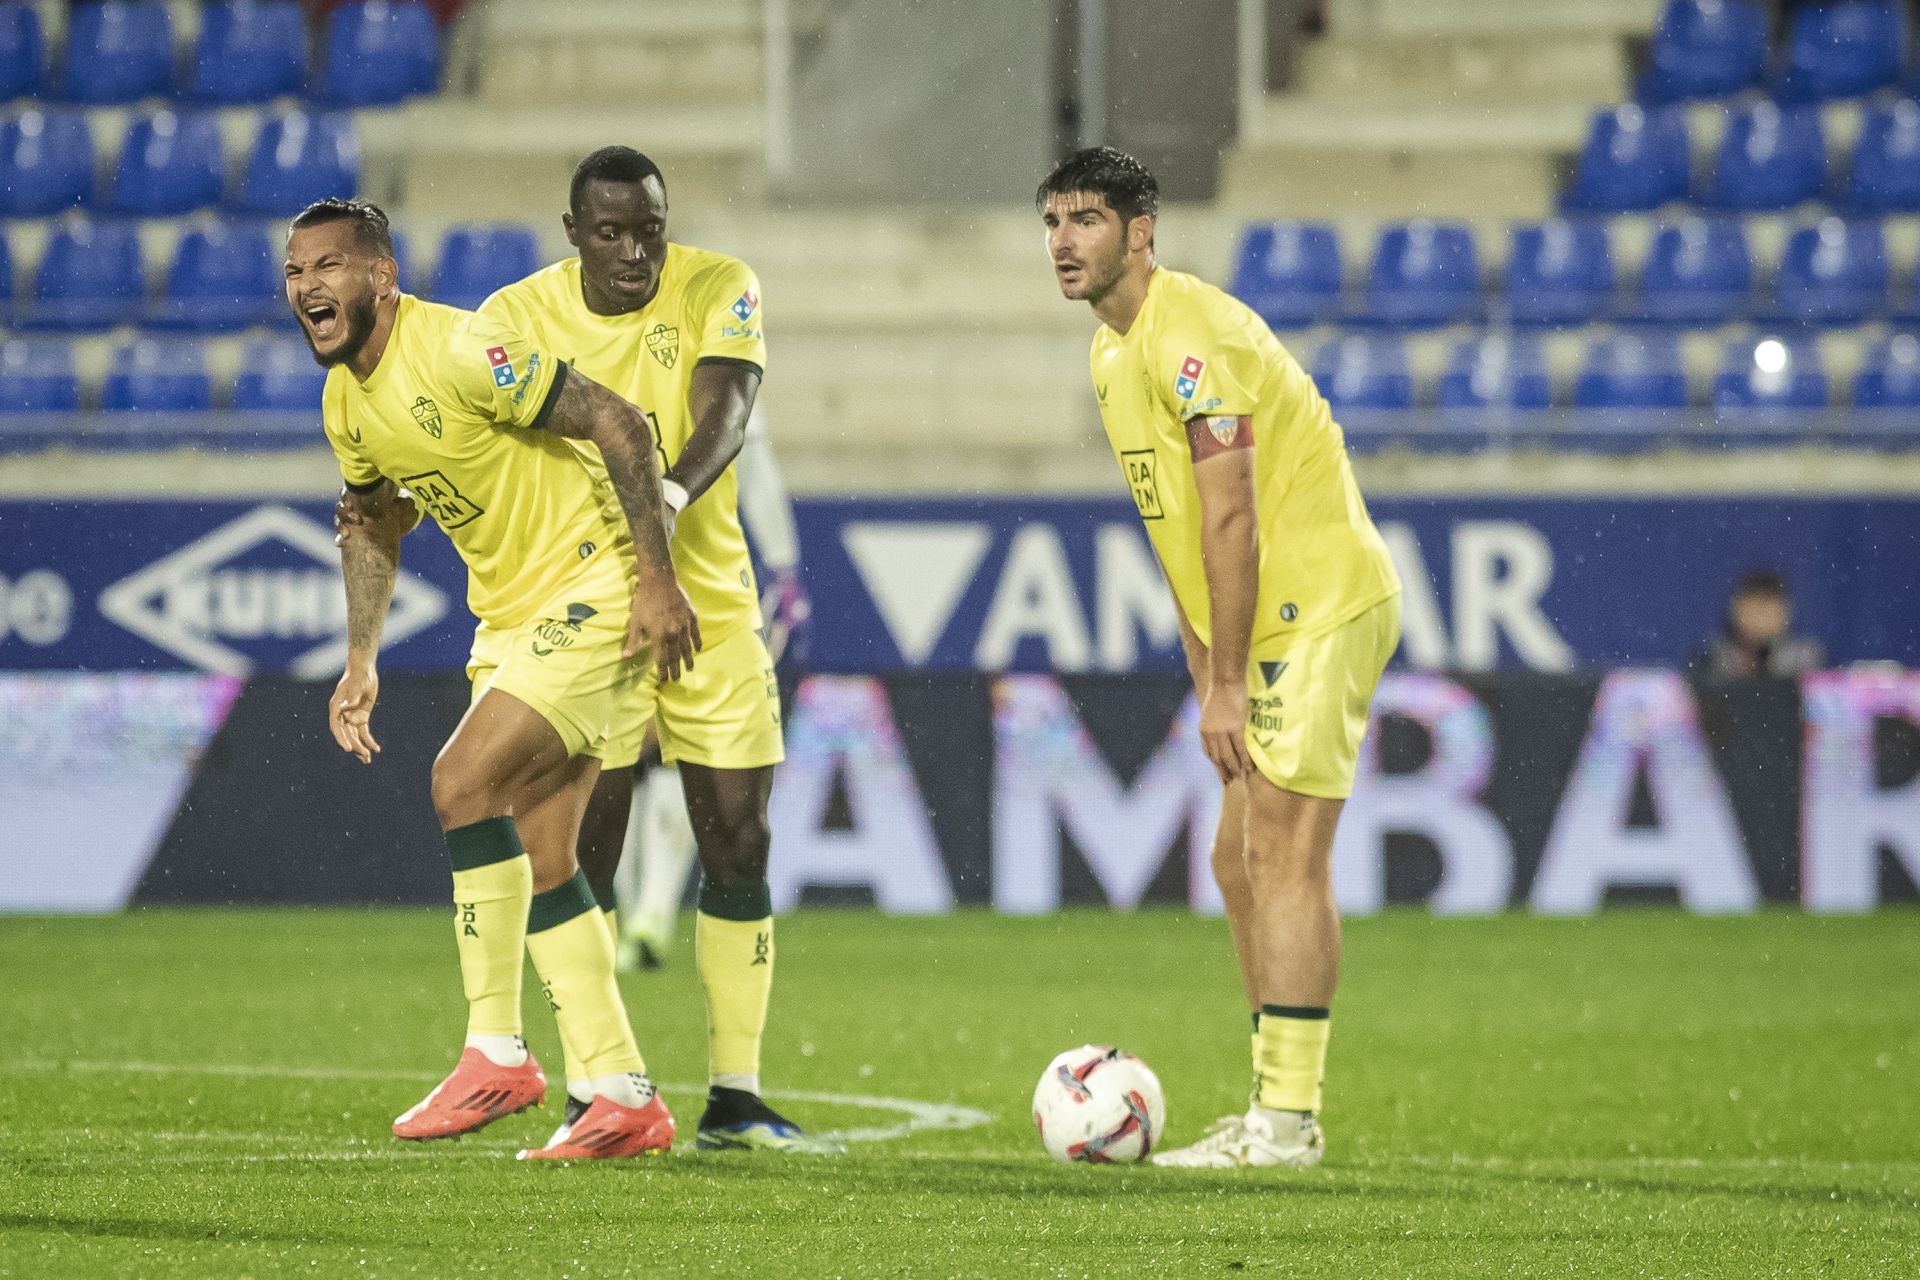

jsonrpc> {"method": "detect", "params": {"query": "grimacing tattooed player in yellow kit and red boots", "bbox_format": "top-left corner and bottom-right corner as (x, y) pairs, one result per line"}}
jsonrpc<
(286, 200), (701, 1159)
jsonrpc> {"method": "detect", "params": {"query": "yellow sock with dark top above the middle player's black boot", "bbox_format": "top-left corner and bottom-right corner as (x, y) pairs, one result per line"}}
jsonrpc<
(693, 881), (774, 1094)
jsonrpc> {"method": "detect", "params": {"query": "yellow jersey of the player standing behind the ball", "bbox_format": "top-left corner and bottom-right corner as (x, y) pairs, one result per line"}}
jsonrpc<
(1092, 267), (1400, 652)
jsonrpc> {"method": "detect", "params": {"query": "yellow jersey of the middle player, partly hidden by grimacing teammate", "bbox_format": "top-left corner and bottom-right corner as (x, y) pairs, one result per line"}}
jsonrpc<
(480, 244), (766, 645)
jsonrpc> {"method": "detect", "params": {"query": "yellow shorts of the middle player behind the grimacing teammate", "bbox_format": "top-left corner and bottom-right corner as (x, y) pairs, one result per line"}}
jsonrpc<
(591, 626), (787, 770)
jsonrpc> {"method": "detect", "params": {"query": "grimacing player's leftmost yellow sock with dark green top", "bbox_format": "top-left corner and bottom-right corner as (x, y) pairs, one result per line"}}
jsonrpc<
(447, 818), (534, 1036)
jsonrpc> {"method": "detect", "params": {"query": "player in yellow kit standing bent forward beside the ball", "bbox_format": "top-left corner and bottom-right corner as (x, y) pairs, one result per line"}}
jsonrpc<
(1037, 148), (1400, 1169)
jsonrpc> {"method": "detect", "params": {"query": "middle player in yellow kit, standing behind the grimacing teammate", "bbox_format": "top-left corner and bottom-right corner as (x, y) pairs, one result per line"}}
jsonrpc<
(480, 146), (839, 1153)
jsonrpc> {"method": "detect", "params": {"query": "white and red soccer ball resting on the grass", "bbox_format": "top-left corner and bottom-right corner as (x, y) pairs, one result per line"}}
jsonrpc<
(1033, 1044), (1167, 1165)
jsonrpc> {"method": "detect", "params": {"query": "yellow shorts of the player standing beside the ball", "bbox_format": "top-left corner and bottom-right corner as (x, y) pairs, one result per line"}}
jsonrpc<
(1246, 595), (1400, 800)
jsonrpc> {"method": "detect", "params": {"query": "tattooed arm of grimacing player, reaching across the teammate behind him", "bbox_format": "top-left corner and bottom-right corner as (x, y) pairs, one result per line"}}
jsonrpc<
(545, 370), (701, 681)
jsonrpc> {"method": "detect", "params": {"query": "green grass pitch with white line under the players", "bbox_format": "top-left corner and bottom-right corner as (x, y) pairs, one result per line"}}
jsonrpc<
(0, 910), (1920, 1278)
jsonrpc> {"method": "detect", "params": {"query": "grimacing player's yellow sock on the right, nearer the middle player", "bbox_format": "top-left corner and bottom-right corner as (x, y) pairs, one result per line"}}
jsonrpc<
(526, 873), (647, 1079)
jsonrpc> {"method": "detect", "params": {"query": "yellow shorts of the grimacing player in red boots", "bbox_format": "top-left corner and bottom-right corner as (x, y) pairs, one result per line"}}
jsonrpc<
(467, 601), (653, 756)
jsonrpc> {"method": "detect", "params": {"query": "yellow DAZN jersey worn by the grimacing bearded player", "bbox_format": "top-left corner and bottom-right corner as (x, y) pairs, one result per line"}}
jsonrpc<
(321, 294), (637, 628)
